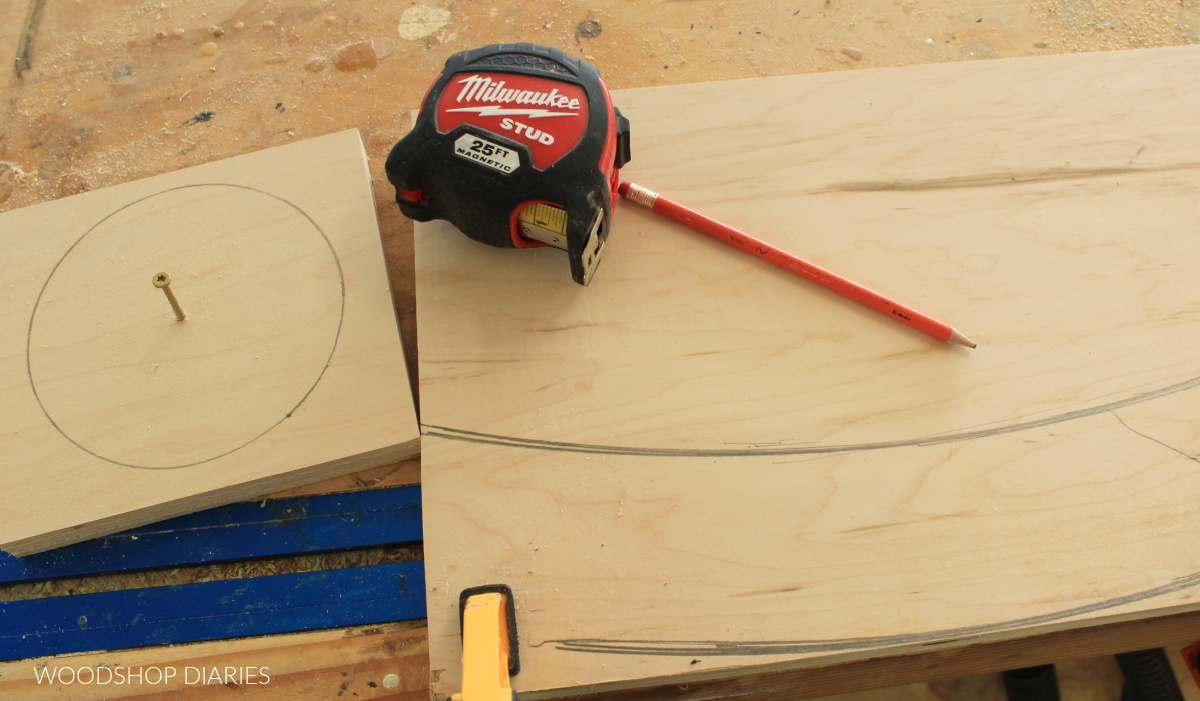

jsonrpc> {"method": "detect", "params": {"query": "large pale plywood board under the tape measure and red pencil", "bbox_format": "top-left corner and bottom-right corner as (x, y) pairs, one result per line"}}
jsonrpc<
(416, 48), (1200, 697)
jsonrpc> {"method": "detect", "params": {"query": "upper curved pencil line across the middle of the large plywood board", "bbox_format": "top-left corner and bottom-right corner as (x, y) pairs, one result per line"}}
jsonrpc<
(421, 377), (1200, 457)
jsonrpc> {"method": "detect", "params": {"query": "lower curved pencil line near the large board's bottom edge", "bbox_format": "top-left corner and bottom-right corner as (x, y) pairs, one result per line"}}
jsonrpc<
(542, 573), (1200, 657)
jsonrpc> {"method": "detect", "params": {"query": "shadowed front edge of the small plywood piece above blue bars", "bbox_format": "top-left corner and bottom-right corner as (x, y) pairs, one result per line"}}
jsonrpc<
(0, 437), (421, 557)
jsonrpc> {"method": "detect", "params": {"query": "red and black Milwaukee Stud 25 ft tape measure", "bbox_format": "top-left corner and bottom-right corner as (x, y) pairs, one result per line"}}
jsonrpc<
(386, 43), (630, 284)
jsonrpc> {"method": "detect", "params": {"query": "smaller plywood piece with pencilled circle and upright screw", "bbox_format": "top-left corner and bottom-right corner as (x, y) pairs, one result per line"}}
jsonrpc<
(0, 131), (419, 556)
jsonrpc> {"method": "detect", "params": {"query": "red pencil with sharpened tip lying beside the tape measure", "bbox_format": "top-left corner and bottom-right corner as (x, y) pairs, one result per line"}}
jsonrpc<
(618, 180), (976, 348)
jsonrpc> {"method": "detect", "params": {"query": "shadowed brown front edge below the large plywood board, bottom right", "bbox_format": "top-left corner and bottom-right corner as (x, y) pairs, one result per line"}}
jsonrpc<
(528, 610), (1200, 701)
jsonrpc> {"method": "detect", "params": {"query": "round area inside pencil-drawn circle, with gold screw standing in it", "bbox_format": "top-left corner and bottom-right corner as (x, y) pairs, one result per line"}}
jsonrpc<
(25, 184), (344, 469)
